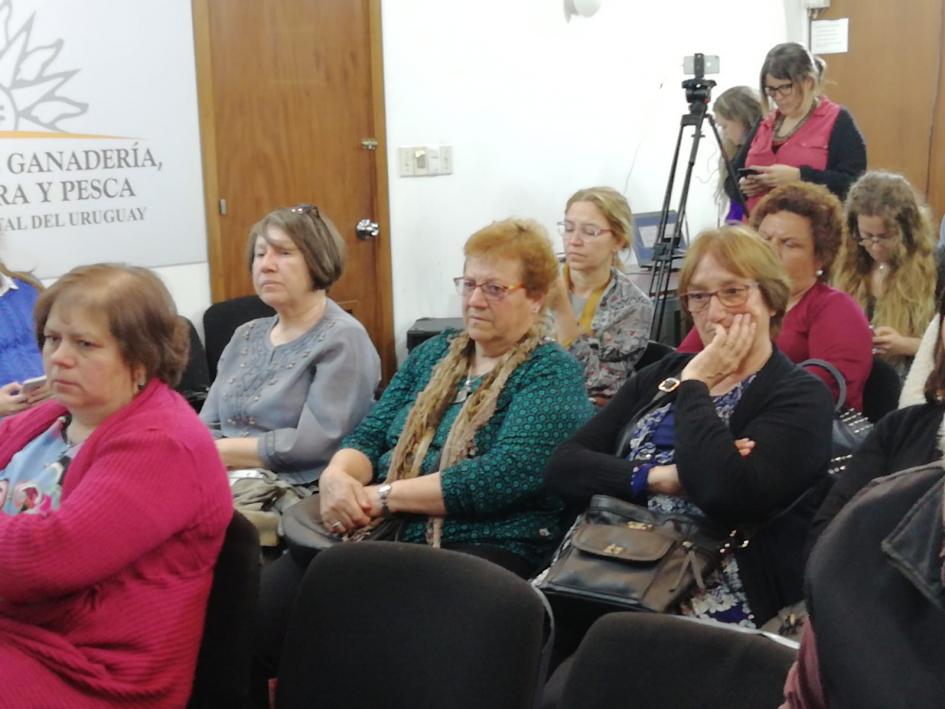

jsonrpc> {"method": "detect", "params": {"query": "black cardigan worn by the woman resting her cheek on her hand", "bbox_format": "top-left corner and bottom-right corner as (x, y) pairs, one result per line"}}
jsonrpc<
(545, 355), (833, 526)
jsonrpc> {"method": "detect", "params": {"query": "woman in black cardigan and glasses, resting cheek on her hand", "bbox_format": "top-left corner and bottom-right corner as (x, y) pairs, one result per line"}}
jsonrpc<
(546, 226), (832, 626)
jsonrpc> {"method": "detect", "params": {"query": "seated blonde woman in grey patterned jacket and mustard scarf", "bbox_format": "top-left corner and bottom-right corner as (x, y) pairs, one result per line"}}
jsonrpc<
(548, 187), (653, 404)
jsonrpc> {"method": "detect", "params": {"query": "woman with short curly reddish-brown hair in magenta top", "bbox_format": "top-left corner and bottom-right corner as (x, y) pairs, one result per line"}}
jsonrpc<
(679, 182), (873, 409)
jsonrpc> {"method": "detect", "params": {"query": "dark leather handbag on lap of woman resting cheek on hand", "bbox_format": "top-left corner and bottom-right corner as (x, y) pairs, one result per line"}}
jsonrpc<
(539, 495), (746, 613)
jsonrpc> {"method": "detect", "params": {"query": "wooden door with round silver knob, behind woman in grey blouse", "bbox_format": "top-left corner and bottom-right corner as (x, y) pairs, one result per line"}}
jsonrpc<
(193, 0), (395, 378)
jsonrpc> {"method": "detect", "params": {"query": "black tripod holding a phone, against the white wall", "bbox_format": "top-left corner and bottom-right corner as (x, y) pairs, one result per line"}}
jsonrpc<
(649, 60), (748, 344)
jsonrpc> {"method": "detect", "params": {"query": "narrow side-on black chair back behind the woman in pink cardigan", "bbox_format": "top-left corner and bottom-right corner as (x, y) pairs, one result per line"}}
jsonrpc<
(187, 511), (259, 709)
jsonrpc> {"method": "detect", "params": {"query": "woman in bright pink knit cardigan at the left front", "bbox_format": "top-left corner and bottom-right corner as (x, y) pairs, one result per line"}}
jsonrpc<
(0, 265), (232, 709)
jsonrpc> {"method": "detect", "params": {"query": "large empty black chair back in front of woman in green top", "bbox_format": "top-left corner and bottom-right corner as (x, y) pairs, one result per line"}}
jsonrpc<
(276, 542), (545, 709)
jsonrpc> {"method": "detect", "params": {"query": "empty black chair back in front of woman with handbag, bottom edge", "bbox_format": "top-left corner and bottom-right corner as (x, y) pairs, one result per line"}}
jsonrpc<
(558, 613), (796, 709)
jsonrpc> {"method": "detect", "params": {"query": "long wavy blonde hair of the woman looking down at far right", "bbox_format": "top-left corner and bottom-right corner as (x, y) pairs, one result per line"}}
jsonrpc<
(833, 170), (936, 344)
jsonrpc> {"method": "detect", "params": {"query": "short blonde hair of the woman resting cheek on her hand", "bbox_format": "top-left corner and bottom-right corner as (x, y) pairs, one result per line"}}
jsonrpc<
(679, 224), (791, 340)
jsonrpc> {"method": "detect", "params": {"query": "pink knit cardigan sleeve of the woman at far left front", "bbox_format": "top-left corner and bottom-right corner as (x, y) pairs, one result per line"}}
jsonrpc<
(0, 429), (227, 602)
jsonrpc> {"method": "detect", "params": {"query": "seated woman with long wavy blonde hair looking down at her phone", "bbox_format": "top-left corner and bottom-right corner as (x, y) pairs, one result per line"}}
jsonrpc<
(833, 171), (936, 374)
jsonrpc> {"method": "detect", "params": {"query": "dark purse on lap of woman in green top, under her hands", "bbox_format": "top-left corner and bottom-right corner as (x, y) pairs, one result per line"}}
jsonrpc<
(282, 493), (403, 564)
